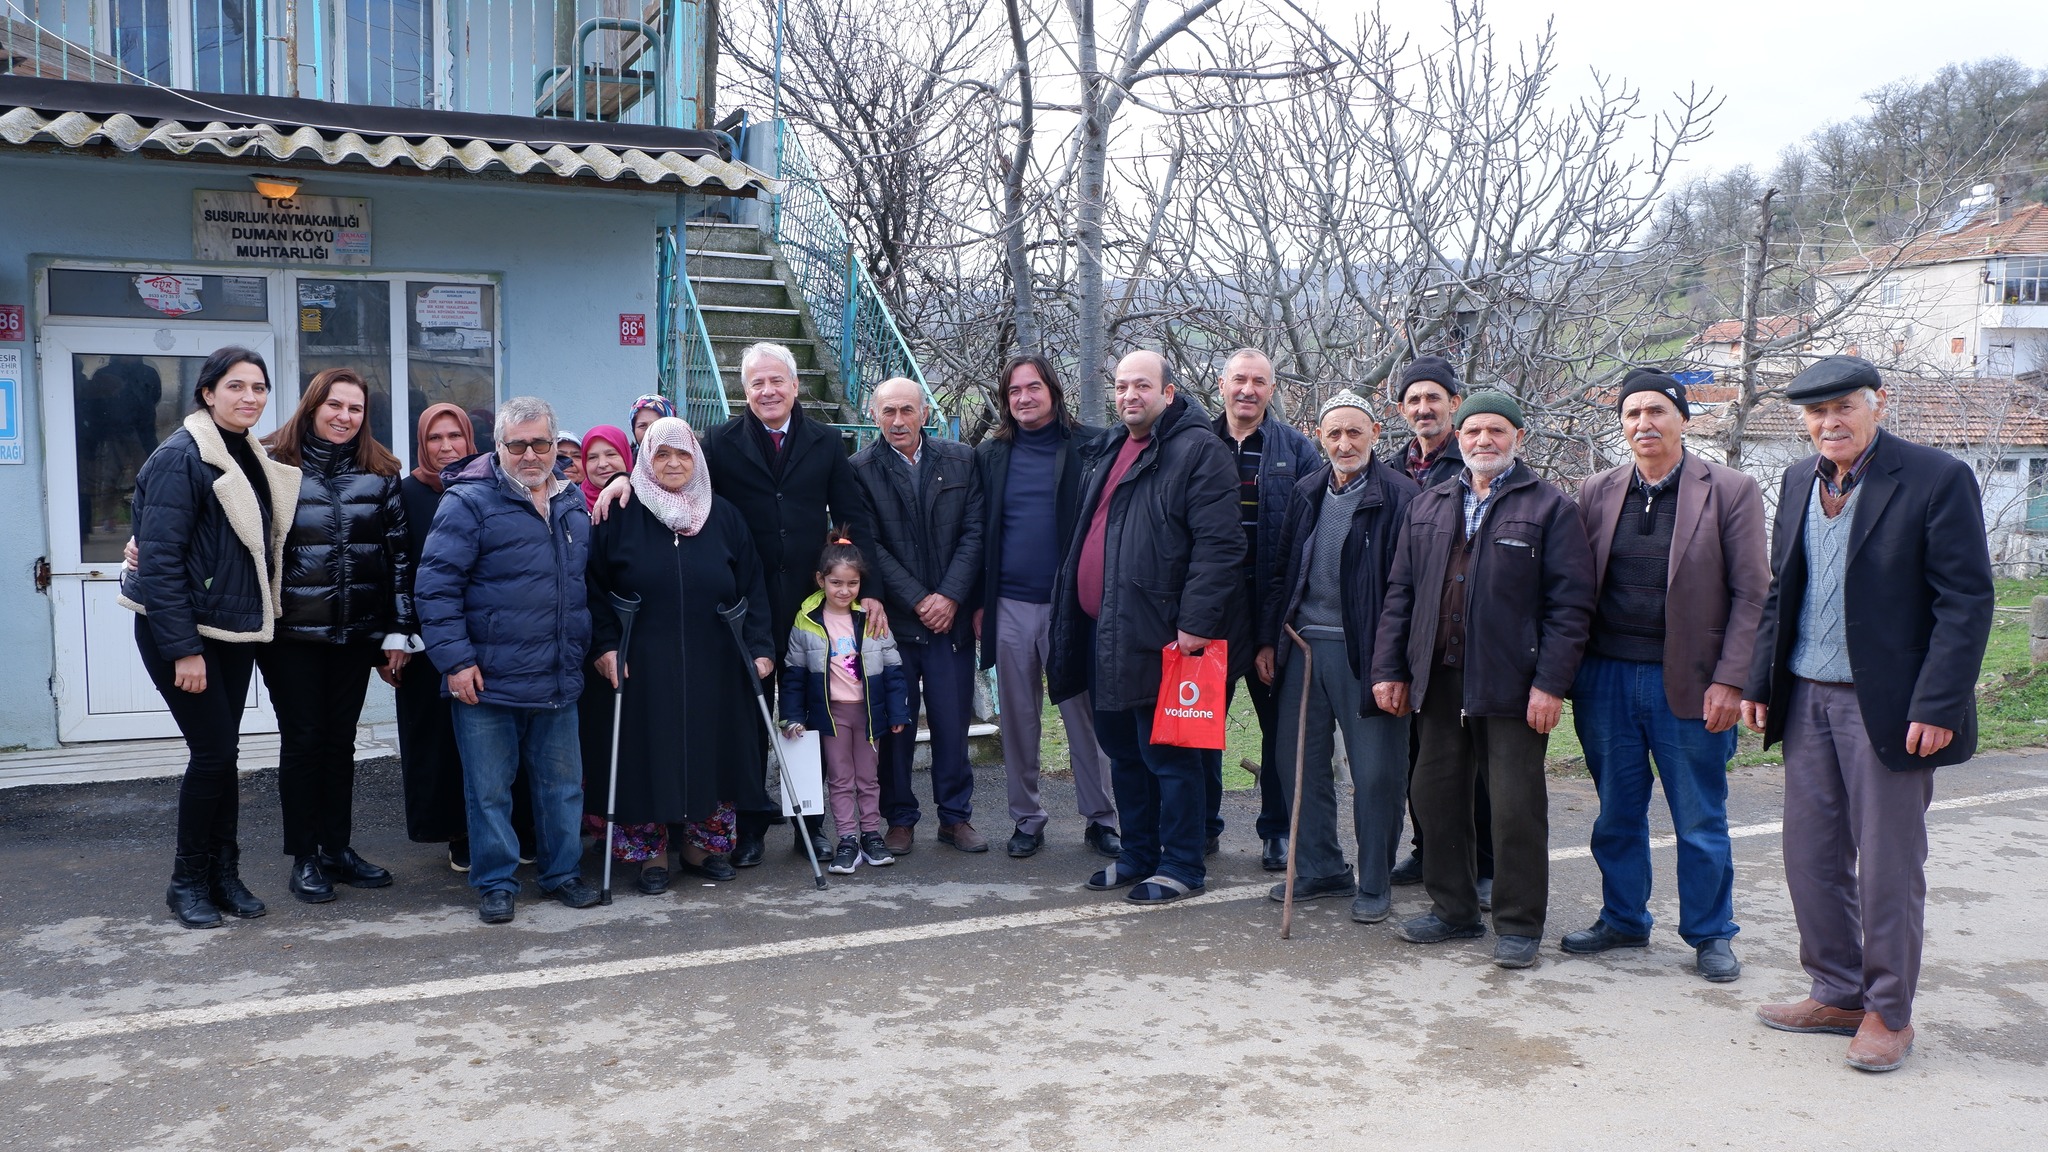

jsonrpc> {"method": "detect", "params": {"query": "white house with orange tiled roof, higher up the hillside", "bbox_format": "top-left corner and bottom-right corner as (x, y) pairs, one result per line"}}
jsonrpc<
(1819, 184), (2048, 377)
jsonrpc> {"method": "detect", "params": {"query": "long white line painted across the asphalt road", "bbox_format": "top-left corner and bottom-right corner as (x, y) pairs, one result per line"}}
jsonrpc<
(0, 787), (2048, 1050)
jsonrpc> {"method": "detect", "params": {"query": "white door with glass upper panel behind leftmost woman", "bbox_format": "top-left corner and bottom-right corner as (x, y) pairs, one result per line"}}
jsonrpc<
(39, 317), (282, 742)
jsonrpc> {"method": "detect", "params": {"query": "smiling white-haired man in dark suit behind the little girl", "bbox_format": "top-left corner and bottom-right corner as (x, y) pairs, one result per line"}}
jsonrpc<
(705, 344), (889, 867)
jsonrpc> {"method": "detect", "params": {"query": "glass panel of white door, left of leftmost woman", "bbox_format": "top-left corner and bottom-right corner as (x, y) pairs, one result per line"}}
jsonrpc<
(72, 355), (205, 564)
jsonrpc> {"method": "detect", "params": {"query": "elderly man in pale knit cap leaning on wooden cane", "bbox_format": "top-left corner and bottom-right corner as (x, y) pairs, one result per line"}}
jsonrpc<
(1257, 389), (1417, 924)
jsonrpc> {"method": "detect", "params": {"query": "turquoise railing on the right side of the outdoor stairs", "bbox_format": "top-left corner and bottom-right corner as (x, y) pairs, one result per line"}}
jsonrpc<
(770, 121), (948, 441)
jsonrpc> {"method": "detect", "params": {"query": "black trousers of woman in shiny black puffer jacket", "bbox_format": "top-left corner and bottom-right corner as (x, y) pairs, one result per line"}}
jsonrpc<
(256, 640), (379, 857)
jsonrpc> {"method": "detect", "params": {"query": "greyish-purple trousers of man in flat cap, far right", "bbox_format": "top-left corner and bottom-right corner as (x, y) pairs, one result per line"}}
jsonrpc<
(1784, 681), (1933, 1029)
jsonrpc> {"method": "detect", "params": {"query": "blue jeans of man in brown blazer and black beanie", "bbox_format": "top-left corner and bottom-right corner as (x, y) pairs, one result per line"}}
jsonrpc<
(1571, 656), (1739, 947)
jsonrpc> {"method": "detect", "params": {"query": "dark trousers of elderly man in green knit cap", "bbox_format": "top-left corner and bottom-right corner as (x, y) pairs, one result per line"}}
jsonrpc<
(1409, 666), (1550, 939)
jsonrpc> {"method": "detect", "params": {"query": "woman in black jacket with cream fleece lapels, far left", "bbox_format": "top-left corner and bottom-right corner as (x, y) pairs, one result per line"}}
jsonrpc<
(121, 348), (299, 929)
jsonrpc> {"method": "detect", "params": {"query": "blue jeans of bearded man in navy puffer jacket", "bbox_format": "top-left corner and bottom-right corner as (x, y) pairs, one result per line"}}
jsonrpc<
(449, 701), (584, 892)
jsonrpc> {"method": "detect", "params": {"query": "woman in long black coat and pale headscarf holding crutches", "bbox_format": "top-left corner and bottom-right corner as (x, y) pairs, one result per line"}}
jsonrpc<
(584, 416), (774, 894)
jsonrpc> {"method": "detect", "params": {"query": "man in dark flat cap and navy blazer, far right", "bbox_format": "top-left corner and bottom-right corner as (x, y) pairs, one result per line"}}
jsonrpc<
(1743, 357), (1993, 1072)
